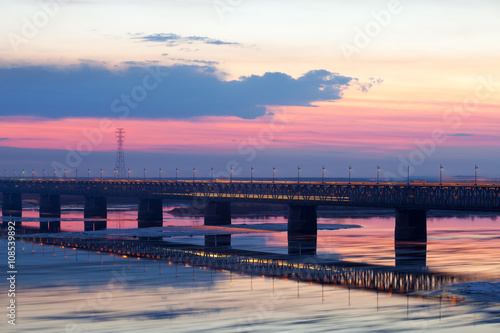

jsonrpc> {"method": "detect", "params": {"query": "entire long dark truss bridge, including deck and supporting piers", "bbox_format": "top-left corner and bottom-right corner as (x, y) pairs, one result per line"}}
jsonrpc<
(0, 179), (500, 241)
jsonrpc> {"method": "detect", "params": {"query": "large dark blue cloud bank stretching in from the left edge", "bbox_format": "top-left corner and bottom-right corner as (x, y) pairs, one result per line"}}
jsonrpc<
(0, 65), (358, 119)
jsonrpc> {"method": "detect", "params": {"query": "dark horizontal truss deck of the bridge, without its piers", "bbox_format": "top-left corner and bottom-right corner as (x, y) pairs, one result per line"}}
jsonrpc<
(0, 179), (500, 211)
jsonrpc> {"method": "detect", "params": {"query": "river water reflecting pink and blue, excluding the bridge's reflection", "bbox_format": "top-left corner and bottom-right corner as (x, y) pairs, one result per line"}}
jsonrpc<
(0, 207), (500, 332)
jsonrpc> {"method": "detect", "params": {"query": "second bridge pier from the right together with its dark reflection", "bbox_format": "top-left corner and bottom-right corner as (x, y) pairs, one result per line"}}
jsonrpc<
(288, 204), (318, 255)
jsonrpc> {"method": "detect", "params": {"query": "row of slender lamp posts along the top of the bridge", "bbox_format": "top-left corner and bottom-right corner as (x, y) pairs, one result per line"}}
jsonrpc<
(4, 165), (479, 185)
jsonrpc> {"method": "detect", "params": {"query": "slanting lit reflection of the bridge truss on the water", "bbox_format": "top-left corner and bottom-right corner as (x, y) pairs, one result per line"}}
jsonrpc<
(24, 236), (459, 293)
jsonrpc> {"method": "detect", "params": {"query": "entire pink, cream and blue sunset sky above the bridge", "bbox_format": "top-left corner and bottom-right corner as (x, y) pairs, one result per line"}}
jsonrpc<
(0, 0), (500, 180)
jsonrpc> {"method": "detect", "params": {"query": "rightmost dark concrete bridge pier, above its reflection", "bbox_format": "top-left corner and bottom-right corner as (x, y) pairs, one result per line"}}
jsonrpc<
(394, 208), (427, 242)
